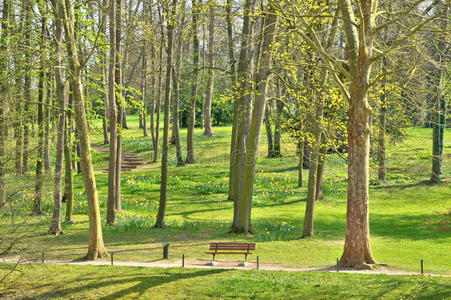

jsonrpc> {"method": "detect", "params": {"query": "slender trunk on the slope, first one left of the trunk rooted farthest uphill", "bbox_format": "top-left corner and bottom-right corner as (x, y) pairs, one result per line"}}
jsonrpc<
(186, 0), (202, 164)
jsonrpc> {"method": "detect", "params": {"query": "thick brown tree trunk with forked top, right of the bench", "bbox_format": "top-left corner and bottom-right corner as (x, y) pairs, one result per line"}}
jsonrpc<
(339, 0), (377, 268)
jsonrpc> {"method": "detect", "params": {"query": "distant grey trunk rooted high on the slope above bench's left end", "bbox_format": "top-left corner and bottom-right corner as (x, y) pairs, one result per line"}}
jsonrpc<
(204, 0), (216, 136)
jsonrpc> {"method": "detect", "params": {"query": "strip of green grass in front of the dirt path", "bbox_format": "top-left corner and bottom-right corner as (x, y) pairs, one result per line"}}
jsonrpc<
(0, 265), (451, 299)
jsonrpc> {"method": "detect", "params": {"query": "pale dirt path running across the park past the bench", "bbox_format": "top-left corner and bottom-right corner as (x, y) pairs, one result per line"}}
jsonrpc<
(2, 258), (451, 277)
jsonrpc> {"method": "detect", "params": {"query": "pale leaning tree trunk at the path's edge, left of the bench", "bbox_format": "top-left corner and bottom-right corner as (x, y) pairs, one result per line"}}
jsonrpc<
(58, 0), (107, 260)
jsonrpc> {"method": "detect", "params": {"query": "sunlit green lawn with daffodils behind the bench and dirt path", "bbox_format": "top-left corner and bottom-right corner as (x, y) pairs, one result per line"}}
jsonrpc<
(0, 116), (451, 274)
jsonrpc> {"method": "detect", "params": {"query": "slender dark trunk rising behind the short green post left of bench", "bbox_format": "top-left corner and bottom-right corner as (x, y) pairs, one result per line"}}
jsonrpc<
(155, 0), (177, 228)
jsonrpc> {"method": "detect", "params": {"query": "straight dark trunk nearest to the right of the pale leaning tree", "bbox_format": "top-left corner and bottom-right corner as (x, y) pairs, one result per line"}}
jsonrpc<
(106, 0), (118, 225)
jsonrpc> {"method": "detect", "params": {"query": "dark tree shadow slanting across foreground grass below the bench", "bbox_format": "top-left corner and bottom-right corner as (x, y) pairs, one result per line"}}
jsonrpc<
(34, 270), (228, 299)
